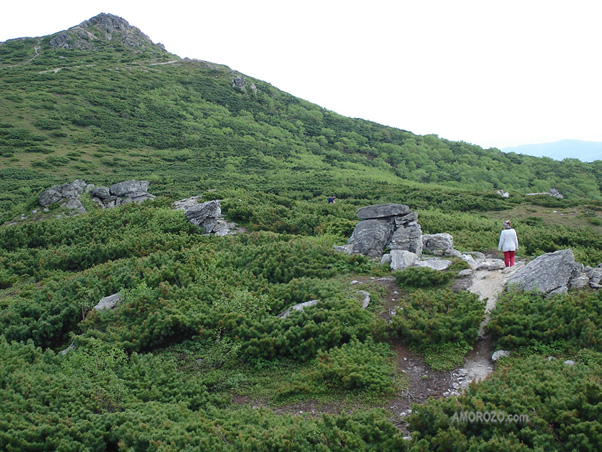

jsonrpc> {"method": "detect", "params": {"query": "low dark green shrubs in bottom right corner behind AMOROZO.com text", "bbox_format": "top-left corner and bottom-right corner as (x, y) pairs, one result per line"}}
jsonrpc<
(409, 352), (602, 451)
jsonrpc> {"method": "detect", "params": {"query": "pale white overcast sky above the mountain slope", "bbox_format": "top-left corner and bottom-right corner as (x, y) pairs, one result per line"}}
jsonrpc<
(0, 0), (602, 149)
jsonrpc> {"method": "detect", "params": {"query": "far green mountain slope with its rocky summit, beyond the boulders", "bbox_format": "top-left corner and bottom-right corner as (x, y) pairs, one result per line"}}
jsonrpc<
(0, 15), (602, 225)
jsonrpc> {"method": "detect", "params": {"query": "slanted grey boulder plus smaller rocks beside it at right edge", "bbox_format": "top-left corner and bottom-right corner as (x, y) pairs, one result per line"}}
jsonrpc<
(507, 249), (602, 295)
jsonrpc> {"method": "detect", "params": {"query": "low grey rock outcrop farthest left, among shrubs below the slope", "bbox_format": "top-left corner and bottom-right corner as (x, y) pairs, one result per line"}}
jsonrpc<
(38, 179), (155, 213)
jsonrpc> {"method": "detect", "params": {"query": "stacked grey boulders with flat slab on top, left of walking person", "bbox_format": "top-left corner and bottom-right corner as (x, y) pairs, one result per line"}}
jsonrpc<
(335, 204), (504, 276)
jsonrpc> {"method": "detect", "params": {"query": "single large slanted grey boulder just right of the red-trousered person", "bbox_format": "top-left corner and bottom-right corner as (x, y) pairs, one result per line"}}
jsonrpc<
(507, 249), (576, 294)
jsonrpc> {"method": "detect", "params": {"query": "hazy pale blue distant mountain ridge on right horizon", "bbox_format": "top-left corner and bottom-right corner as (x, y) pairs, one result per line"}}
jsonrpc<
(502, 140), (602, 162)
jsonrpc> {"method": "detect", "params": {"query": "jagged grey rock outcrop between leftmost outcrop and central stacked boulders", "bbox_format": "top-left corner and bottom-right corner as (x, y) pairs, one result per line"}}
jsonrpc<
(171, 195), (242, 236)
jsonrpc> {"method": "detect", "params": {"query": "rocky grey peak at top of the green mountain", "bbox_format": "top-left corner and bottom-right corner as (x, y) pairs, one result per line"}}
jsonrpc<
(48, 13), (166, 52)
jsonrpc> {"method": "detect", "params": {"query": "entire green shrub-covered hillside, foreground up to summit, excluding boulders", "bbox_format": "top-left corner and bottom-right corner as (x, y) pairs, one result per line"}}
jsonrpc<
(0, 14), (602, 451)
